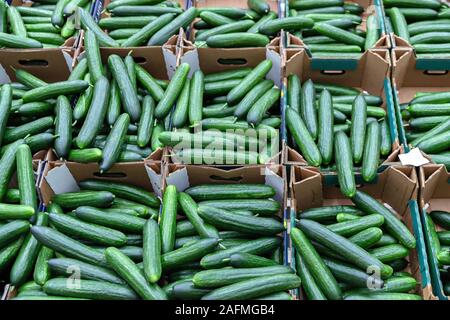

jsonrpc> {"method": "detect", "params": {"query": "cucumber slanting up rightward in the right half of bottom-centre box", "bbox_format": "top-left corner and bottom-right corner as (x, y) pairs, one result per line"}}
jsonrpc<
(200, 237), (281, 269)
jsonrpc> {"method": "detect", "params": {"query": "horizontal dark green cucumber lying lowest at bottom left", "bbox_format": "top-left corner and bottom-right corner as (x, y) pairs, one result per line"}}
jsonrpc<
(44, 278), (138, 300)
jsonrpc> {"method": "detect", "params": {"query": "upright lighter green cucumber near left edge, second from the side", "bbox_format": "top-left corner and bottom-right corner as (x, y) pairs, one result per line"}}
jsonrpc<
(16, 144), (38, 210)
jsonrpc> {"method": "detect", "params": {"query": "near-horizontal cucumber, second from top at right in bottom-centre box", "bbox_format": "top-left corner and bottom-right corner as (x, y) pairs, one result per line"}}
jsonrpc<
(198, 199), (280, 215)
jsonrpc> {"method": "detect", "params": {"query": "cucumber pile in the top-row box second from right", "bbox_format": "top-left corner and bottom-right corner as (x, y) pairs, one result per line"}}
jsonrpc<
(284, 0), (381, 57)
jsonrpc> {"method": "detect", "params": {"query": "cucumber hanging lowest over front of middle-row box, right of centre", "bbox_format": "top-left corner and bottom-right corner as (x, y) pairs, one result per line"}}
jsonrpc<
(334, 131), (356, 197)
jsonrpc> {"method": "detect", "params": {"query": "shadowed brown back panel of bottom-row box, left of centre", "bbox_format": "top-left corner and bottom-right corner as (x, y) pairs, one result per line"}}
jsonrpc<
(39, 161), (161, 204)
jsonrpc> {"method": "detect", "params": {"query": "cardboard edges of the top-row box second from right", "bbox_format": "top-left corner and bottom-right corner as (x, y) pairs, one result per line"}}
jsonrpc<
(286, 0), (392, 68)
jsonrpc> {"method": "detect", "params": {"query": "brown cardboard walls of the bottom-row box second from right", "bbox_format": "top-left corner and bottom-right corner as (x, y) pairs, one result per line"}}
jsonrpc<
(288, 166), (433, 300)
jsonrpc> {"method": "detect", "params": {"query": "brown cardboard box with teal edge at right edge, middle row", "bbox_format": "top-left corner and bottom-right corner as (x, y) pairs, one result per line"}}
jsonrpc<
(392, 48), (450, 156)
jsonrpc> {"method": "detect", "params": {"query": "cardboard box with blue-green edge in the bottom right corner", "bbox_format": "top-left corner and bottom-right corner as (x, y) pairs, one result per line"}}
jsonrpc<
(419, 165), (450, 300)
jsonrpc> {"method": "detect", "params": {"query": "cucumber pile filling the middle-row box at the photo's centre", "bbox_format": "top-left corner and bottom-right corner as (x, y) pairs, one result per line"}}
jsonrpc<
(155, 60), (281, 164)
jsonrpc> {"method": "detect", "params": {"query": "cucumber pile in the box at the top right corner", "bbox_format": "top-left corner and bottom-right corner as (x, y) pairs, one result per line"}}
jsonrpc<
(383, 0), (450, 58)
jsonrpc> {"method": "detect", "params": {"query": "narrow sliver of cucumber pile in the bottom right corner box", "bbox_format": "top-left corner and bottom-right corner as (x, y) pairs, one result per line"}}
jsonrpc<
(426, 211), (450, 296)
